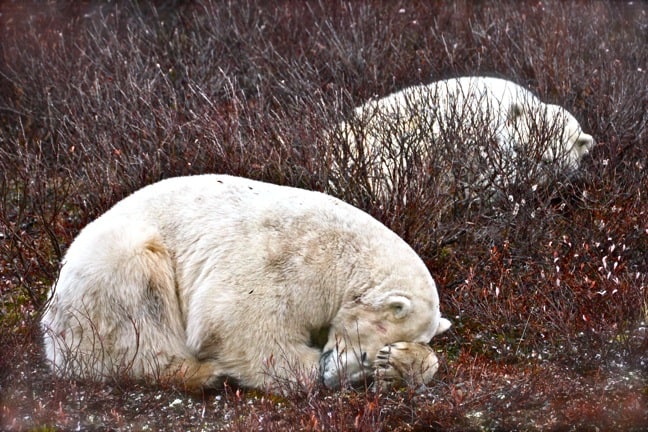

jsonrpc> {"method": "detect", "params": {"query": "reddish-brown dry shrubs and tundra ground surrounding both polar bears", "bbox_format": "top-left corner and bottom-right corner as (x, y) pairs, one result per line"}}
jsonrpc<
(0, 0), (648, 431)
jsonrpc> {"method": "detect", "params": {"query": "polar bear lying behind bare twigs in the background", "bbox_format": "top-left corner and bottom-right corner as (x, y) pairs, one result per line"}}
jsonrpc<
(331, 77), (594, 198)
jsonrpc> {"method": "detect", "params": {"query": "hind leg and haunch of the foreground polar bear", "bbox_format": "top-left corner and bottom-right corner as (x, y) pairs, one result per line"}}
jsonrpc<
(43, 220), (220, 387)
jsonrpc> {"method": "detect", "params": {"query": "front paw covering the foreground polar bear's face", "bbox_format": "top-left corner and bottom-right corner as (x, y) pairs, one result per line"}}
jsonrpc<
(374, 342), (439, 390)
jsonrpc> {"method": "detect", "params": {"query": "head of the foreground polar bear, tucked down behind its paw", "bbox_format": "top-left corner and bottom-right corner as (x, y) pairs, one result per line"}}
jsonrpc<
(320, 246), (450, 387)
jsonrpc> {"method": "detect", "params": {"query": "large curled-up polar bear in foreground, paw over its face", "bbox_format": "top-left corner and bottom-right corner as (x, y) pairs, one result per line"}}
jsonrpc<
(42, 175), (450, 388)
